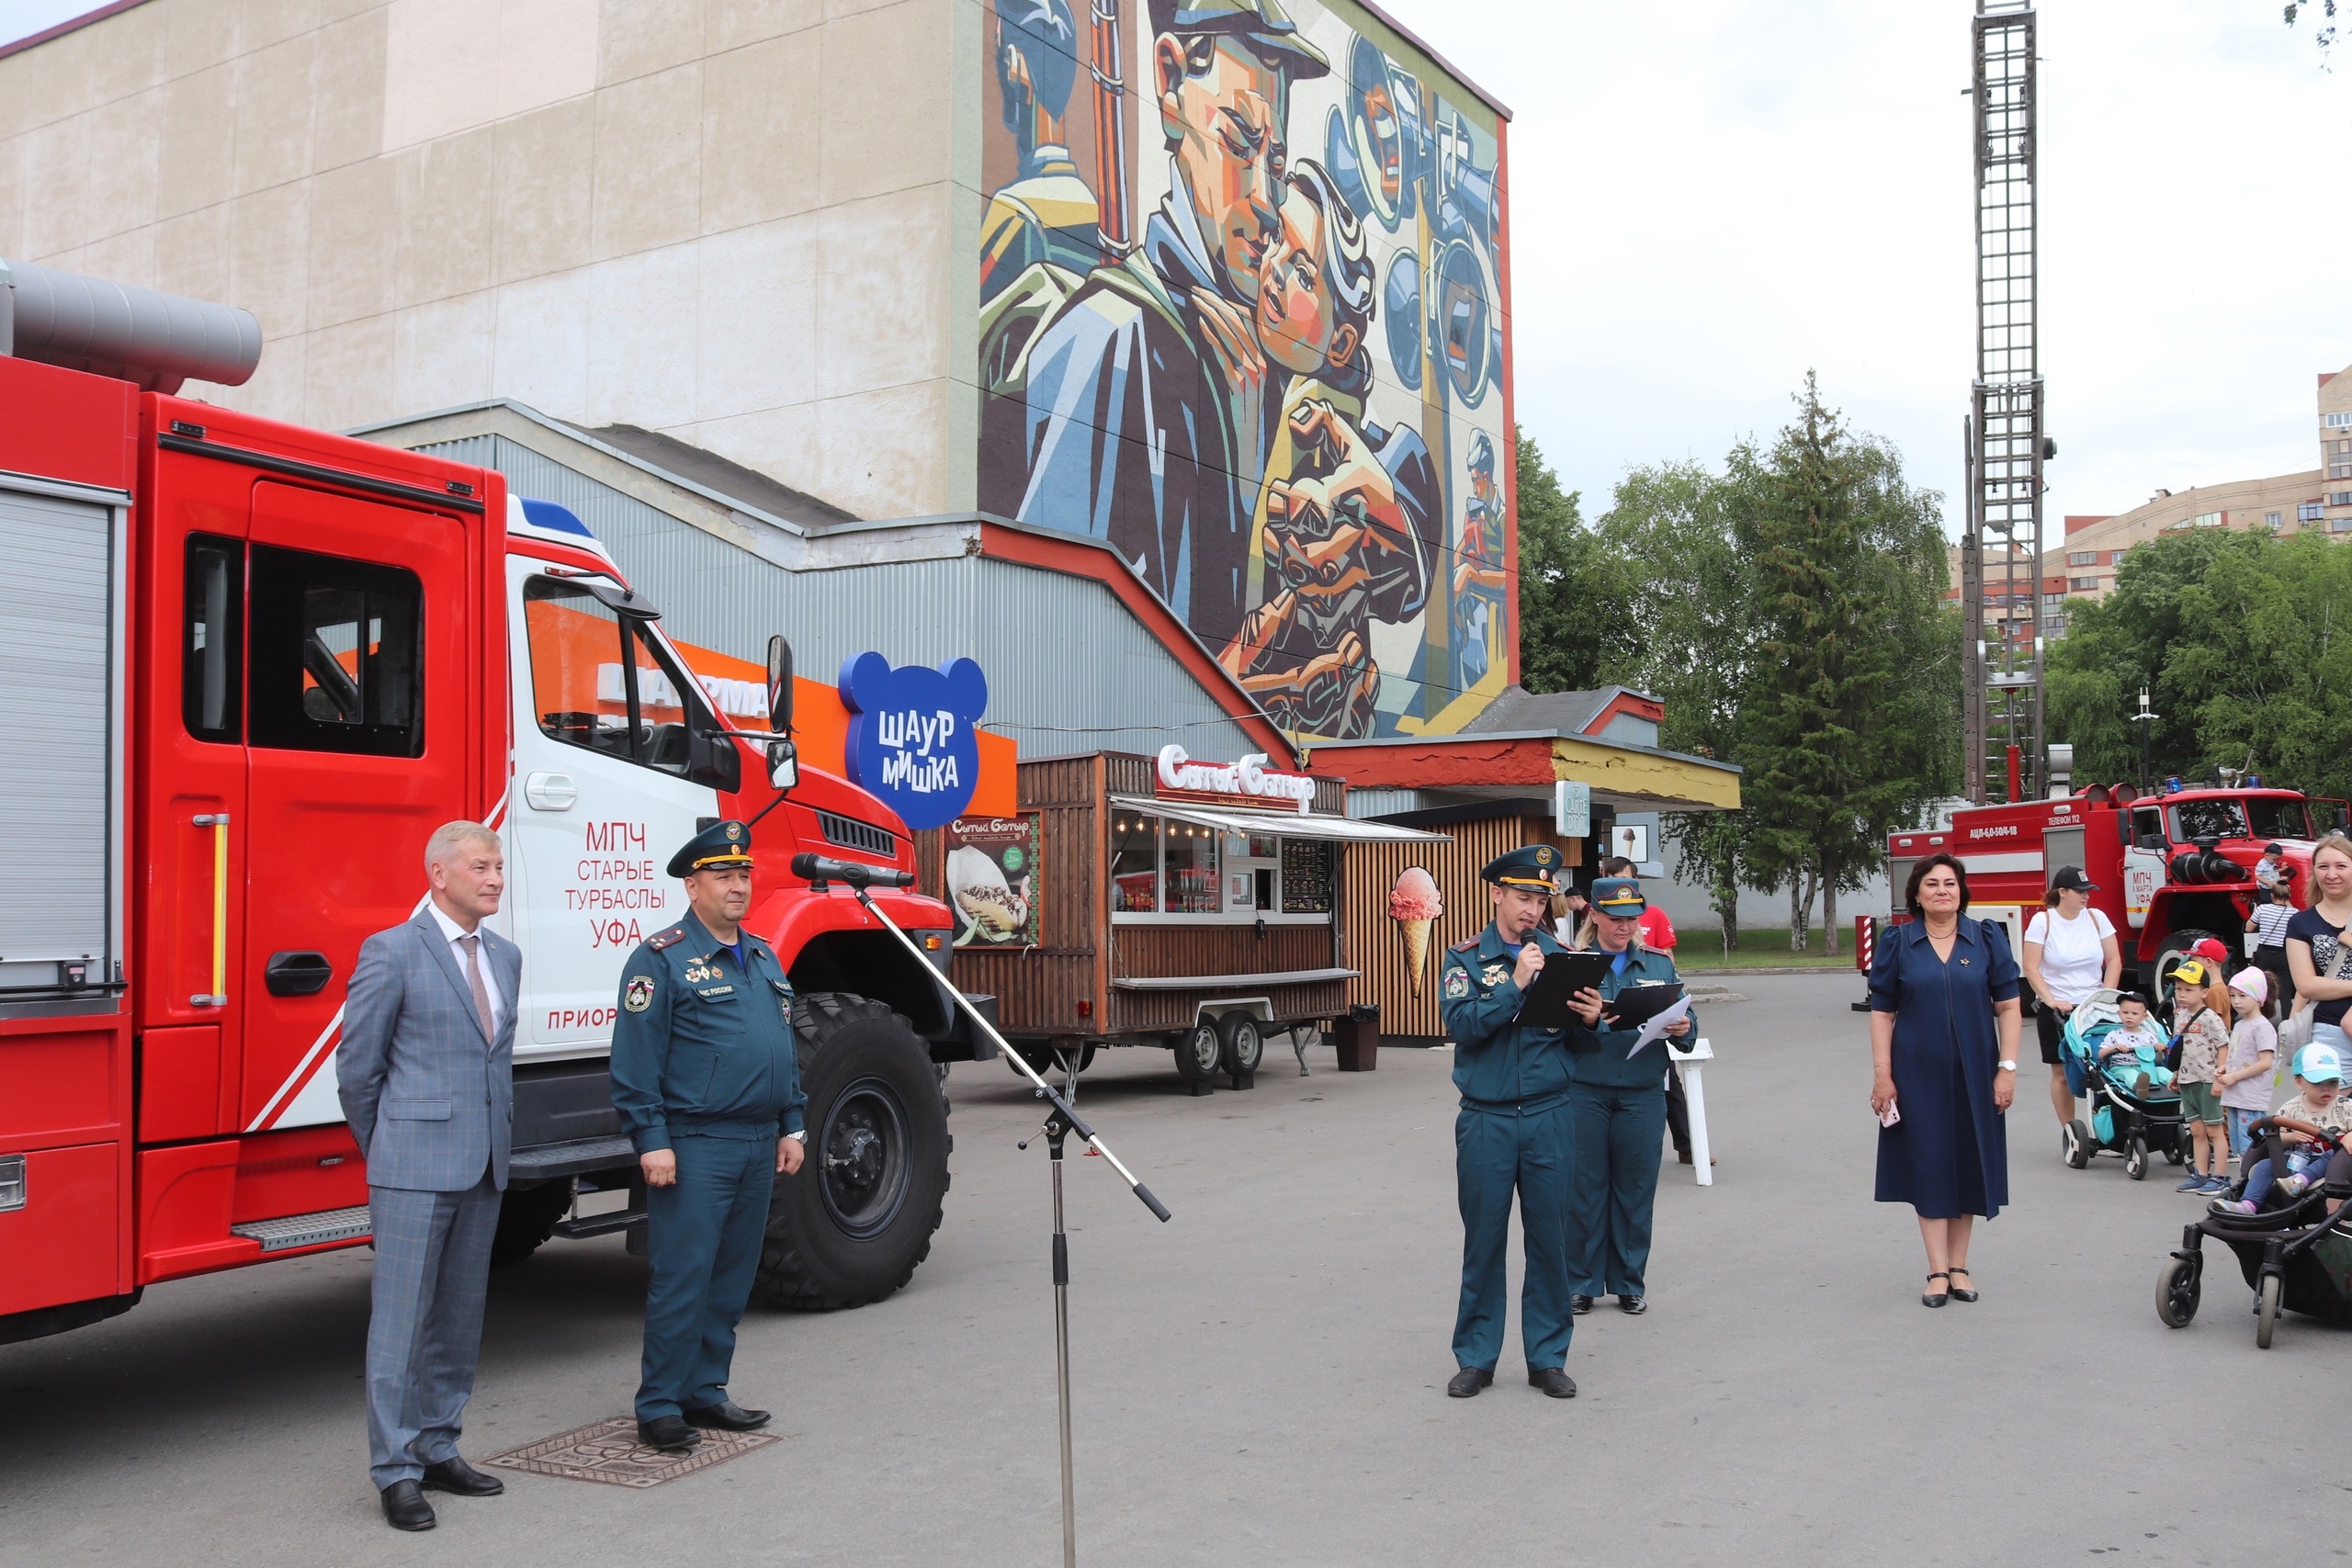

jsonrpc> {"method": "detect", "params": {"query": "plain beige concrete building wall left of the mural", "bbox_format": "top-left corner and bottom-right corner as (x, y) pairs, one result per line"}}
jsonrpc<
(0, 0), (981, 517)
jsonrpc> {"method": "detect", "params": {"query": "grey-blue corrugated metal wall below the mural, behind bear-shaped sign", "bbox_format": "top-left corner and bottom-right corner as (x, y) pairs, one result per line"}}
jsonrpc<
(419, 434), (1259, 757)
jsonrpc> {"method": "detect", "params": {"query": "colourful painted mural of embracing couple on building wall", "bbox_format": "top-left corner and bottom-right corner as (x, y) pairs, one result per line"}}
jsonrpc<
(978, 0), (1517, 739)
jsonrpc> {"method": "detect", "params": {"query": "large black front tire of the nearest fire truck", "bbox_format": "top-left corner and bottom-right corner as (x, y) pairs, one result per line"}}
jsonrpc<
(755, 992), (955, 1312)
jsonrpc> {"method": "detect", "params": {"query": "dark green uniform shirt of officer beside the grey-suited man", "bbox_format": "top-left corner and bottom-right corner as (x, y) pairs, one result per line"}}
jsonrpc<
(612, 915), (809, 1155)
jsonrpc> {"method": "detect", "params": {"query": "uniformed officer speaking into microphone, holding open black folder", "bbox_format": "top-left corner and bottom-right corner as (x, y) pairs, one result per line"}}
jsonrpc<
(1440, 844), (1576, 1399)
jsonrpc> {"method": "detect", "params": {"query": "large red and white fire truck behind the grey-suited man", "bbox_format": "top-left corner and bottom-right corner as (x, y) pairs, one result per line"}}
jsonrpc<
(0, 264), (978, 1342)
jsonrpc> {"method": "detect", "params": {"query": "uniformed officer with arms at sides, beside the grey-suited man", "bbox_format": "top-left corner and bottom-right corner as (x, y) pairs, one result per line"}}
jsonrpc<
(612, 823), (807, 1453)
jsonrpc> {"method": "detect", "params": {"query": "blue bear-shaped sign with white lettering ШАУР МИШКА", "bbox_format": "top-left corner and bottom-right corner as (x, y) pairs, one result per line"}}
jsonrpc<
(840, 653), (988, 828)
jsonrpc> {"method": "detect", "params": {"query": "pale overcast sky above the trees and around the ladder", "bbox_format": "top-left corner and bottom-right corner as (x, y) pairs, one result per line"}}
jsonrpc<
(0, 0), (2352, 541)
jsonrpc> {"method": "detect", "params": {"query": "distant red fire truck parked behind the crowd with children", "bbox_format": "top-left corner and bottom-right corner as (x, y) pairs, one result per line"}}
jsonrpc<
(1886, 785), (2345, 997)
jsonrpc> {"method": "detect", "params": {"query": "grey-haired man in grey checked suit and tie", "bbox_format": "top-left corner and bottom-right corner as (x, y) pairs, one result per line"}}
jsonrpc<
(334, 823), (522, 1530)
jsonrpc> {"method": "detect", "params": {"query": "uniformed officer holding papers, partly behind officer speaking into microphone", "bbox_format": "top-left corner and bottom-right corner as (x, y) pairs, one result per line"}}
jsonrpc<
(1569, 877), (1696, 1314)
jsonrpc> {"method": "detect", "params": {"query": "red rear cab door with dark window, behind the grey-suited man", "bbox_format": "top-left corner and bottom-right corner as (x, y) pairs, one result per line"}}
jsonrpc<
(243, 479), (480, 1131)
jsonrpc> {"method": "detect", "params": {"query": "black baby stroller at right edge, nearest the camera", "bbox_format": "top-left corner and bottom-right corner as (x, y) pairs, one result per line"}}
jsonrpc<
(2157, 1117), (2352, 1349)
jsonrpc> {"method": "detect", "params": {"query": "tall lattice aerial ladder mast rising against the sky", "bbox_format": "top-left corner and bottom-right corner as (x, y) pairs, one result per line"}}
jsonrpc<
(1959, 0), (2051, 804)
